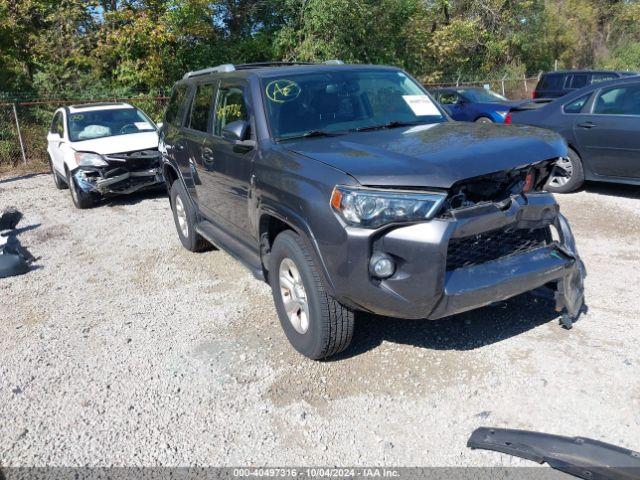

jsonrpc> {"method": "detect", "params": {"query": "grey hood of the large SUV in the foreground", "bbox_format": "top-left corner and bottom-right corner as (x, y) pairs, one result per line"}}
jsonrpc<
(282, 122), (567, 188)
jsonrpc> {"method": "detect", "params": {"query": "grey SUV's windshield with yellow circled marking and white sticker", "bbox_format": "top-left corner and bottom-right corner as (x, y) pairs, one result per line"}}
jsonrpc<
(262, 70), (446, 140)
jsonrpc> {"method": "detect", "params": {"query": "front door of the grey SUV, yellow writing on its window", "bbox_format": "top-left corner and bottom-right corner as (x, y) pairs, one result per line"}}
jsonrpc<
(206, 79), (255, 239)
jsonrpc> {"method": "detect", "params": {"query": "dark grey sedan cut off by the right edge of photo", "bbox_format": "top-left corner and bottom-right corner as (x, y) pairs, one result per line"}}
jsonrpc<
(505, 76), (640, 193)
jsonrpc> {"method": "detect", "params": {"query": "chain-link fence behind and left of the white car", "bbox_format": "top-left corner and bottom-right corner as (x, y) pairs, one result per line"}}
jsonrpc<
(0, 96), (168, 173)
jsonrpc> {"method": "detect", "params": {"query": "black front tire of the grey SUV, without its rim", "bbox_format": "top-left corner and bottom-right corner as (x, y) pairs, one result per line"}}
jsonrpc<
(269, 230), (354, 360)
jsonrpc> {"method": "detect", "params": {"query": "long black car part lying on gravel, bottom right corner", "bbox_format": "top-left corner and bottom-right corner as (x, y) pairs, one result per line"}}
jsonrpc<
(467, 427), (640, 480)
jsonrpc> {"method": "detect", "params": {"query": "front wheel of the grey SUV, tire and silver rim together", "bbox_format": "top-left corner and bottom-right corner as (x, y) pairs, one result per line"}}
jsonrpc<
(269, 230), (354, 360)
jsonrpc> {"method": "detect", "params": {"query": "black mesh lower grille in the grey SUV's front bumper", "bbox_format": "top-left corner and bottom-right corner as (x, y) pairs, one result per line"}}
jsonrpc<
(447, 228), (548, 270)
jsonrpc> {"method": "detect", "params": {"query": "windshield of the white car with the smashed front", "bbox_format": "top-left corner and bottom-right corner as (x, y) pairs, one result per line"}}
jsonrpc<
(68, 108), (155, 142)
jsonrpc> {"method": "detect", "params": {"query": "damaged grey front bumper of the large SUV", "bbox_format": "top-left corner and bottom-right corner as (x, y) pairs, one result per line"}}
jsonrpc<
(328, 193), (585, 319)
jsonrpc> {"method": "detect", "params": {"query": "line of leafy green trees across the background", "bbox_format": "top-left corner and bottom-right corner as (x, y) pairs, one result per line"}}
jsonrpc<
(0, 0), (640, 98)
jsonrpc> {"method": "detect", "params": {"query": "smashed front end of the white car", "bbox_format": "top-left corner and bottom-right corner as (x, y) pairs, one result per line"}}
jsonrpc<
(72, 148), (164, 195)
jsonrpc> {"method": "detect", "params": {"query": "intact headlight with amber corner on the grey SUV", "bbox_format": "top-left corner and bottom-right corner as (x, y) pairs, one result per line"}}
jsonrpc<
(331, 185), (446, 228)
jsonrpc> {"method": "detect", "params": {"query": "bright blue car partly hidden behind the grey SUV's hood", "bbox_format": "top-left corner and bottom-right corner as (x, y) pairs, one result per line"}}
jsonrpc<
(431, 87), (522, 123)
